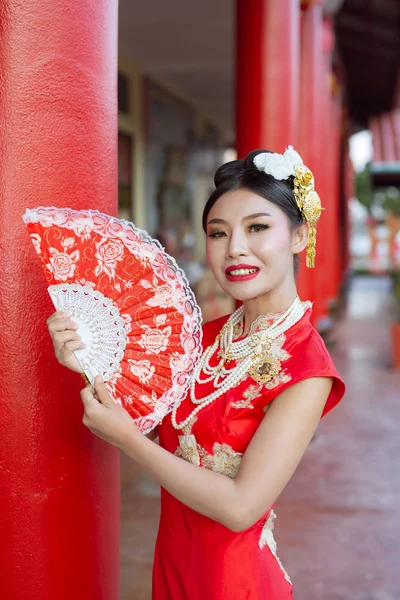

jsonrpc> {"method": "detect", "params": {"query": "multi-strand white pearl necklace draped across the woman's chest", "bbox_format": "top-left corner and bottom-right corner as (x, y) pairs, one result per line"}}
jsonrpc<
(171, 296), (309, 429)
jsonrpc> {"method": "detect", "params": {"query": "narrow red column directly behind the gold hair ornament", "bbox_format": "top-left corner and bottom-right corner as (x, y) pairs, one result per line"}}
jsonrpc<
(297, 2), (325, 314)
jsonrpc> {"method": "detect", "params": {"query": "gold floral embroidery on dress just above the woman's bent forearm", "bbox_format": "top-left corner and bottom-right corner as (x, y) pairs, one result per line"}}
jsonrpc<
(175, 417), (243, 479)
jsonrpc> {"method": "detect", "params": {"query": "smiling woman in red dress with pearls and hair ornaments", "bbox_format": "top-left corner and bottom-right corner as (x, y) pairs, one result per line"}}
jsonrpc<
(48, 147), (344, 600)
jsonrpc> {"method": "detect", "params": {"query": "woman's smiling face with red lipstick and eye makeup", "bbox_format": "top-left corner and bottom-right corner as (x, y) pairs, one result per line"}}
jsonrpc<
(206, 189), (299, 301)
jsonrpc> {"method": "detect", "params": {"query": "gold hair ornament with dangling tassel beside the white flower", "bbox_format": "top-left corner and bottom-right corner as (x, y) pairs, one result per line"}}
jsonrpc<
(293, 165), (324, 269)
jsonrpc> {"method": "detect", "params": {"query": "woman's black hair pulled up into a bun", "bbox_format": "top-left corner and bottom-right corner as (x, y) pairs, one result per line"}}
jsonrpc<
(203, 150), (304, 271)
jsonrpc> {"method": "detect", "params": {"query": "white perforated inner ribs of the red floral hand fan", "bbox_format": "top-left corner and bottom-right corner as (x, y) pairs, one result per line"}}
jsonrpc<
(48, 283), (127, 385)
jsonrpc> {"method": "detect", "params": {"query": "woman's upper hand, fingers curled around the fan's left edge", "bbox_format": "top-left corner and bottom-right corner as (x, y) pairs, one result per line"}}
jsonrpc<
(47, 311), (85, 373)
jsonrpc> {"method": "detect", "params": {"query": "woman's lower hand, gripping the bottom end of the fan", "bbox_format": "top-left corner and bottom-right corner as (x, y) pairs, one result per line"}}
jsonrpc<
(81, 376), (138, 450)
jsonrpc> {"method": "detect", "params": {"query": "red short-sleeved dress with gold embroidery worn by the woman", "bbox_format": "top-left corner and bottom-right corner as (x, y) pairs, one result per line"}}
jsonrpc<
(153, 309), (344, 600)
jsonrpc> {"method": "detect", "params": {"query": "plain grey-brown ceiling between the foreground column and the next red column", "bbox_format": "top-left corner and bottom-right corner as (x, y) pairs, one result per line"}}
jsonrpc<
(119, 0), (234, 131)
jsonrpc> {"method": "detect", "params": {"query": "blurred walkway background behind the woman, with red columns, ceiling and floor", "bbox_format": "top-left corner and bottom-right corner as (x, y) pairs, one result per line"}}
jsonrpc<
(118, 0), (400, 600)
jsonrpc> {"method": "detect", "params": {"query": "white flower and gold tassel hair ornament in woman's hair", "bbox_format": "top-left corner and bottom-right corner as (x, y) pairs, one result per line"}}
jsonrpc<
(253, 146), (324, 268)
